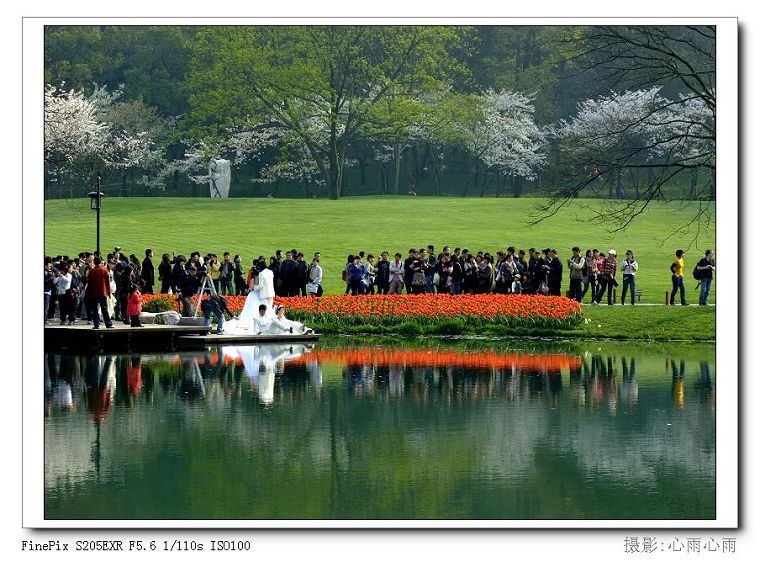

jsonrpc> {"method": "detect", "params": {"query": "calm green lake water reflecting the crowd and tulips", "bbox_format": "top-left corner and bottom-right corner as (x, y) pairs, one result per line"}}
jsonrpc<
(44, 338), (716, 520)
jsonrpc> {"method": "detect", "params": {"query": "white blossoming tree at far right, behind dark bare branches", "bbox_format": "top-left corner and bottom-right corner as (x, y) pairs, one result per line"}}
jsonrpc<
(550, 86), (715, 230)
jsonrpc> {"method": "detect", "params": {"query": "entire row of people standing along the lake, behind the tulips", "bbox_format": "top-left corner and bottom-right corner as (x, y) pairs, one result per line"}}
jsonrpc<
(45, 244), (715, 327)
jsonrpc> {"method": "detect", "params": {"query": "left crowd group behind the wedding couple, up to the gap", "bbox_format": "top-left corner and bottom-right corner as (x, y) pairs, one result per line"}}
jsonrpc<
(44, 246), (323, 328)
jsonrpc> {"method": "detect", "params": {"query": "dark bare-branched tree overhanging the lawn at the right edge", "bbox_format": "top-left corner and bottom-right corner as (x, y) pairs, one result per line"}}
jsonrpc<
(535, 25), (717, 231)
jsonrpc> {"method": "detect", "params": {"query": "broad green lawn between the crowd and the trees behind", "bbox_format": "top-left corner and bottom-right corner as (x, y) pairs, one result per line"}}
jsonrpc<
(45, 192), (717, 302)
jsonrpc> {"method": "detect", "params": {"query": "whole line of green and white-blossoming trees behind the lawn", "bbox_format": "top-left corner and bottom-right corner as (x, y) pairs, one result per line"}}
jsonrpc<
(45, 25), (716, 221)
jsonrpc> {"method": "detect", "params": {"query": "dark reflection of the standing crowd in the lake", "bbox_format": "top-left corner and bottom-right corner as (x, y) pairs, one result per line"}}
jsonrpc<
(45, 345), (713, 414)
